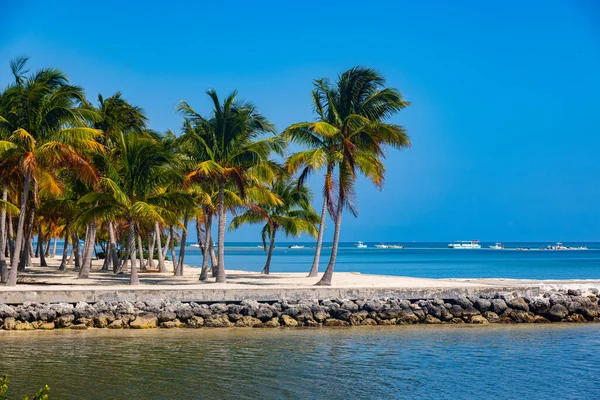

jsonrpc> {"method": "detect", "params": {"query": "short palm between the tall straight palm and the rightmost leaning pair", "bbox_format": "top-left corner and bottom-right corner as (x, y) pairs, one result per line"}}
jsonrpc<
(229, 178), (319, 275)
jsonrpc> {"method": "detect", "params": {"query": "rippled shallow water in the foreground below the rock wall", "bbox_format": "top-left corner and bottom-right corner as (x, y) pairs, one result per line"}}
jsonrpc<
(0, 324), (600, 400)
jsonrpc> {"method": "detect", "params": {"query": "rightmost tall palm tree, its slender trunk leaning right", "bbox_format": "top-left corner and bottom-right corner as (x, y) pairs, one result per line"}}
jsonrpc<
(291, 67), (410, 285)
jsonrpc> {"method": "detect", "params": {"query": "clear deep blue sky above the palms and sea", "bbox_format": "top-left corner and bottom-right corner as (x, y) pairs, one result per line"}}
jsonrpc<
(0, 0), (600, 241)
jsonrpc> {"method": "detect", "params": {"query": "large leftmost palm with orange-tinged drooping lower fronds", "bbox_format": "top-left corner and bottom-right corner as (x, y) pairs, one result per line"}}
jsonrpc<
(0, 58), (103, 286)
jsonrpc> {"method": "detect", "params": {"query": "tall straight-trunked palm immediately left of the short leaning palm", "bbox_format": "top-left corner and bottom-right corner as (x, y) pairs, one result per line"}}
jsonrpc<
(178, 89), (283, 282)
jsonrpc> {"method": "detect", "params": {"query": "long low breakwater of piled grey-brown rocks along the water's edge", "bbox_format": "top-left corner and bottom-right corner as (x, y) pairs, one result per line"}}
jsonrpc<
(0, 289), (600, 330)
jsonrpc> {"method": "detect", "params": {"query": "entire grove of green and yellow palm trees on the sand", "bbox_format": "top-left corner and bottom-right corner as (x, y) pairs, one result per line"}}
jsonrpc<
(0, 58), (410, 285)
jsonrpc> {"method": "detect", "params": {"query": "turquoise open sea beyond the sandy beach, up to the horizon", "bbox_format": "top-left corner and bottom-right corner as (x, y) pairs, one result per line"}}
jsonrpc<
(179, 242), (600, 279)
